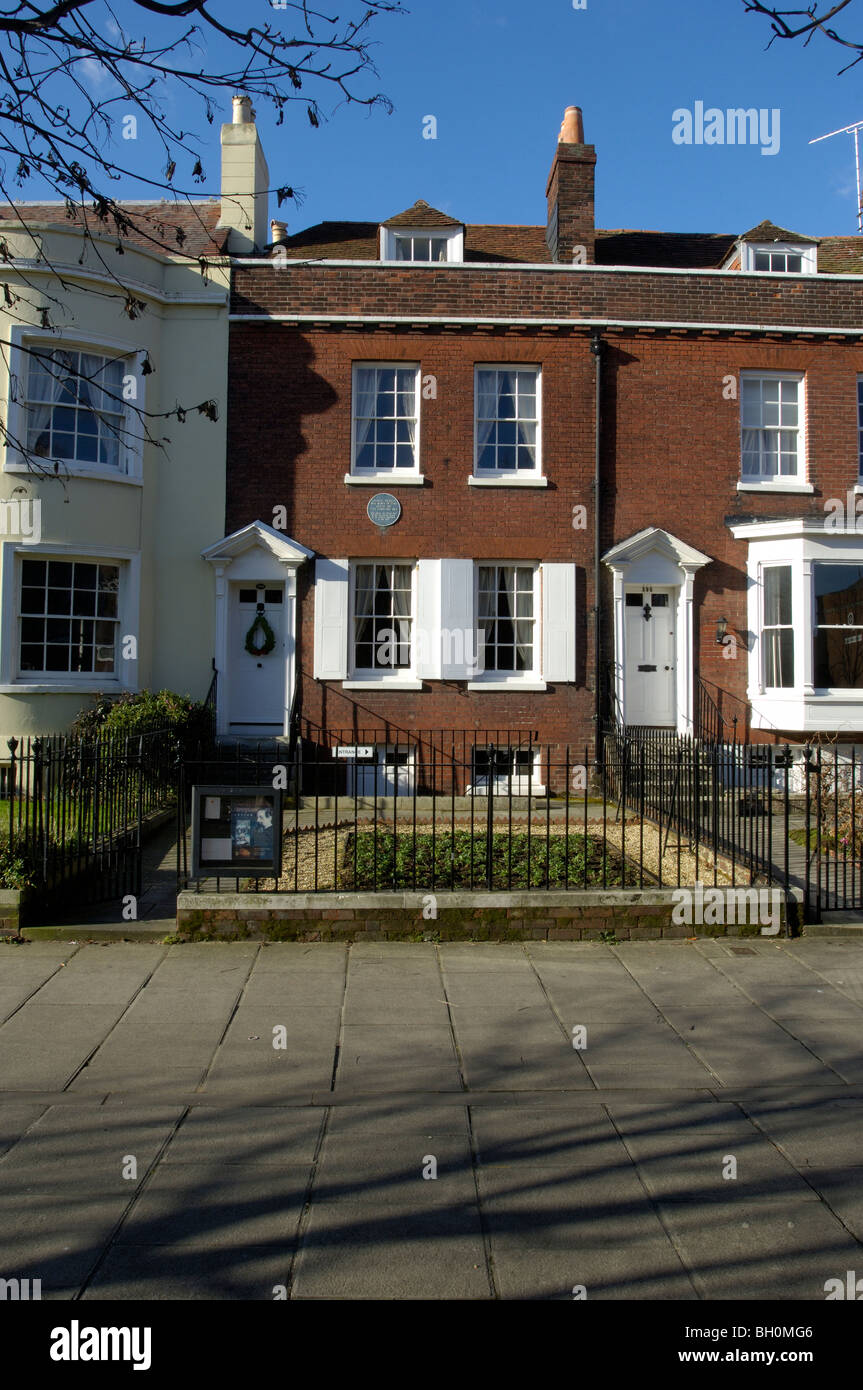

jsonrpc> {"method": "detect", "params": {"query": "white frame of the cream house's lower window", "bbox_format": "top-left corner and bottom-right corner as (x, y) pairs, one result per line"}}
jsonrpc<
(0, 541), (140, 695)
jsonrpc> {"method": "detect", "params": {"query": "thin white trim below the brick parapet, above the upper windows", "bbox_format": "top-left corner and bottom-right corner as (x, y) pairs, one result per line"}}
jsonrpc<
(228, 312), (863, 338)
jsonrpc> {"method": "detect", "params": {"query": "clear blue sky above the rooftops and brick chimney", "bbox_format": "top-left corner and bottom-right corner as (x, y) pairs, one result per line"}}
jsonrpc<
(53, 0), (863, 235)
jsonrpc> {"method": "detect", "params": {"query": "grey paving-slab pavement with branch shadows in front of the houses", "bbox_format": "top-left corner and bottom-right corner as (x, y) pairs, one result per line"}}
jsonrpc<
(0, 938), (863, 1301)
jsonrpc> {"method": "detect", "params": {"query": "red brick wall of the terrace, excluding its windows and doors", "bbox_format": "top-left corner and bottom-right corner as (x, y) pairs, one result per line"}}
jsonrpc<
(227, 115), (863, 748)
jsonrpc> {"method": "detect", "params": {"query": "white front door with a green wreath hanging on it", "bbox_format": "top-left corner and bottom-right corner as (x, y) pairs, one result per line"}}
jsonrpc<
(220, 581), (285, 738)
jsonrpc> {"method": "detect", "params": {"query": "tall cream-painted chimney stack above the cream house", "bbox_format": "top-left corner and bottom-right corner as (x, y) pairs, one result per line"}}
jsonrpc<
(218, 93), (270, 254)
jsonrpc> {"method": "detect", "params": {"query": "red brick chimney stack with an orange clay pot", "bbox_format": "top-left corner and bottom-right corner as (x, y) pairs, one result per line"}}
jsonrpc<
(545, 106), (596, 265)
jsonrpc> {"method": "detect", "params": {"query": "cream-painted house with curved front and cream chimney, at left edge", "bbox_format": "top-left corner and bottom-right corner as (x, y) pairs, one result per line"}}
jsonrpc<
(0, 99), (267, 739)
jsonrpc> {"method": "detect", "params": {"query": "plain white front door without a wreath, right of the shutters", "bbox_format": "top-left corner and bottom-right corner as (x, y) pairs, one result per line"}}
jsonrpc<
(624, 585), (677, 727)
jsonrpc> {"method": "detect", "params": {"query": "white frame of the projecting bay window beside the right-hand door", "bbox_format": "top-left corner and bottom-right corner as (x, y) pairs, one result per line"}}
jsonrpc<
(730, 517), (863, 734)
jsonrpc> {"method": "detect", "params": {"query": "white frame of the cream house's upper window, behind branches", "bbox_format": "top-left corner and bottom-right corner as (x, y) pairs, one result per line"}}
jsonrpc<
(3, 324), (147, 487)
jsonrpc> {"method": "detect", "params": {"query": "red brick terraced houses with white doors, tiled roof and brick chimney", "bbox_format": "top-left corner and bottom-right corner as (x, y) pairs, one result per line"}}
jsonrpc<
(216, 107), (863, 791)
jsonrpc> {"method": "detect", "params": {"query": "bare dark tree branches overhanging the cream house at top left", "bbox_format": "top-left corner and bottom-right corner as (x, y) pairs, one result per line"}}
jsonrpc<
(0, 0), (404, 475)
